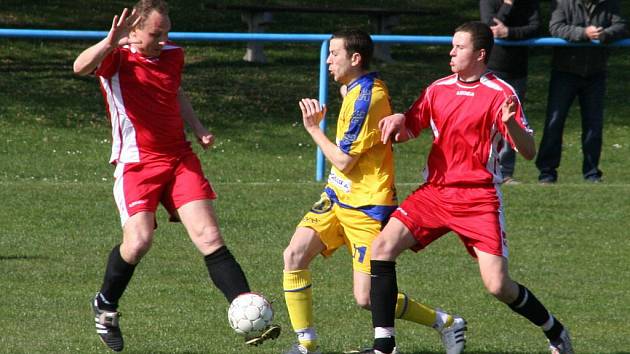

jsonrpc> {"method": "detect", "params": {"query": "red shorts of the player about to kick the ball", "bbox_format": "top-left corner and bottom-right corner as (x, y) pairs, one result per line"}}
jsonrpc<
(114, 152), (217, 225)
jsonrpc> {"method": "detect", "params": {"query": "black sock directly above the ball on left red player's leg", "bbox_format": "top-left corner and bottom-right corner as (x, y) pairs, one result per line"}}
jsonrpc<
(204, 246), (250, 303)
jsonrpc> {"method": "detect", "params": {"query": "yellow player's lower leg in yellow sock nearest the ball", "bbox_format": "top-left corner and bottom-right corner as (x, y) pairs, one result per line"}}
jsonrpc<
(283, 227), (326, 352)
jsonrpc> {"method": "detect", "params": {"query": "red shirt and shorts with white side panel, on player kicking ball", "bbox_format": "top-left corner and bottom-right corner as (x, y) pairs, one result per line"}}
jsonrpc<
(95, 43), (216, 225)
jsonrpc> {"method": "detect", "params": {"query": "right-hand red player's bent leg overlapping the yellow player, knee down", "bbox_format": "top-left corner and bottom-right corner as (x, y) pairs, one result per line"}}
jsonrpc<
(370, 218), (416, 353)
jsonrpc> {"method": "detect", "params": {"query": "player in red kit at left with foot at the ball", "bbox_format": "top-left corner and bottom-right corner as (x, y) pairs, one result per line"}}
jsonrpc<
(74, 0), (280, 351)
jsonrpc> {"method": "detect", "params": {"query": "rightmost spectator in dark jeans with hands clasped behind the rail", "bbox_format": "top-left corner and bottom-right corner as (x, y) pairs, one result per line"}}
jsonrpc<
(536, 0), (626, 184)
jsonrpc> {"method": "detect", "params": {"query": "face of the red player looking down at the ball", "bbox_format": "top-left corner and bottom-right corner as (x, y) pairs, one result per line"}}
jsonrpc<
(130, 11), (171, 57)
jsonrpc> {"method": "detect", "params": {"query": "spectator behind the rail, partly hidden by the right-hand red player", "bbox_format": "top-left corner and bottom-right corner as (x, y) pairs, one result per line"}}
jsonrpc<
(479, 0), (540, 184)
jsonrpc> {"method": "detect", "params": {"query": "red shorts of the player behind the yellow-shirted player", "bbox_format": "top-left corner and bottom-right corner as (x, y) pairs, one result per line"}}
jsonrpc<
(392, 183), (508, 258)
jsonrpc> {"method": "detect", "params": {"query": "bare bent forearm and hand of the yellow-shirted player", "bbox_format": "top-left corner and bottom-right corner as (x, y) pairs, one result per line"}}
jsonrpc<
(299, 98), (360, 173)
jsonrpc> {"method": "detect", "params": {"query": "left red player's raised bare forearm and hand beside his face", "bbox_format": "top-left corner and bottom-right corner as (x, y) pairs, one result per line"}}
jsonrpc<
(73, 8), (140, 75)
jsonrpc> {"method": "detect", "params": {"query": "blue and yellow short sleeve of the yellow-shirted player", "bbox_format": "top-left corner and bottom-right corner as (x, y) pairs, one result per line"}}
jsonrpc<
(339, 85), (392, 156)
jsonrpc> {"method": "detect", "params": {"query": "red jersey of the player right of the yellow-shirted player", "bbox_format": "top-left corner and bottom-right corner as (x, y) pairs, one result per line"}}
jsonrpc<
(405, 73), (533, 186)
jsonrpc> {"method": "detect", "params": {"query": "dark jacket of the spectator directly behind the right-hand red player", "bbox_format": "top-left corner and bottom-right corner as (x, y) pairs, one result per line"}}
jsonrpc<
(479, 0), (540, 79)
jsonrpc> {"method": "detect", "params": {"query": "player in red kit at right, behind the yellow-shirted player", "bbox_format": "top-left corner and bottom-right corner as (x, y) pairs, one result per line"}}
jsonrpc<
(366, 22), (573, 353)
